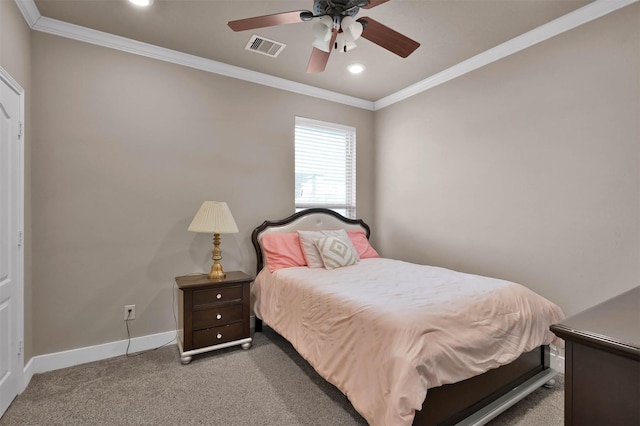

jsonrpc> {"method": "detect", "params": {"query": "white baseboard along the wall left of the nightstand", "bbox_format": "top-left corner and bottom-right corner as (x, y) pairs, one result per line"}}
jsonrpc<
(23, 331), (177, 382)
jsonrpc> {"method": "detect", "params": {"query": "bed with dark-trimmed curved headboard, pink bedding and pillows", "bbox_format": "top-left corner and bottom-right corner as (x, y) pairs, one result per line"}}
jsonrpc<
(252, 208), (564, 426)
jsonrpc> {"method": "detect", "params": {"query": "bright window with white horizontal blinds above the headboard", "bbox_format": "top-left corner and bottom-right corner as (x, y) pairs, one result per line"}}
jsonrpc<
(295, 117), (356, 218)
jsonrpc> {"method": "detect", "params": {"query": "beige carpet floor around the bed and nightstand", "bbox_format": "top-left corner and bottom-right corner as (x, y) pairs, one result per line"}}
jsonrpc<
(0, 328), (563, 426)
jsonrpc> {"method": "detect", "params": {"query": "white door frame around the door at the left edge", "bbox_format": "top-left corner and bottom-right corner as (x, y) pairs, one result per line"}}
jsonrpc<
(0, 66), (26, 402)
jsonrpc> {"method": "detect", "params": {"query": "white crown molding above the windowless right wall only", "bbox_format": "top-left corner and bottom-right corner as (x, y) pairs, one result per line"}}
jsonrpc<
(374, 0), (638, 111)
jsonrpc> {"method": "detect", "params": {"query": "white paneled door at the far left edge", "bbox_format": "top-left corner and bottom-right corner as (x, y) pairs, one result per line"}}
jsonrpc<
(0, 68), (24, 415)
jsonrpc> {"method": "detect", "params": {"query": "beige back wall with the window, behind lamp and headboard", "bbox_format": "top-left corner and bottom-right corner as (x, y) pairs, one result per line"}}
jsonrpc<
(32, 33), (374, 354)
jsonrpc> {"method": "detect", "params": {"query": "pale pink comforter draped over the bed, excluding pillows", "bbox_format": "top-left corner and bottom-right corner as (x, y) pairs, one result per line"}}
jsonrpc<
(252, 258), (564, 426)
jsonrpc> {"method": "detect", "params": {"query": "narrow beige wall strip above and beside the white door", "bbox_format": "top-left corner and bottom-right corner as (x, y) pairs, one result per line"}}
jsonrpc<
(0, 0), (33, 363)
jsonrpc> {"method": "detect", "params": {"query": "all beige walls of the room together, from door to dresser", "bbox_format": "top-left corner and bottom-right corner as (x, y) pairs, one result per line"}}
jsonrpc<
(10, 0), (640, 361)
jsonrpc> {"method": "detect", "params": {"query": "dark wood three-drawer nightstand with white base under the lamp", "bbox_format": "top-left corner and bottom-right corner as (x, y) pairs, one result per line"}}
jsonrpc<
(176, 271), (253, 364)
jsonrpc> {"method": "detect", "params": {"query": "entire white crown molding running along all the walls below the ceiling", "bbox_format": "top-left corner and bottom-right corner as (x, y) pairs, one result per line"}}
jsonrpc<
(15, 0), (640, 111)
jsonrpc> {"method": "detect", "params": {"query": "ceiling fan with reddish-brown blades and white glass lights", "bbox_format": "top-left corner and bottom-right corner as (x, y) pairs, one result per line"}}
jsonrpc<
(228, 0), (420, 73)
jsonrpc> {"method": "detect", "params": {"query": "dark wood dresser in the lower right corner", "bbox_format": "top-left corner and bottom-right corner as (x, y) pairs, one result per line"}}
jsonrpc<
(551, 287), (640, 426)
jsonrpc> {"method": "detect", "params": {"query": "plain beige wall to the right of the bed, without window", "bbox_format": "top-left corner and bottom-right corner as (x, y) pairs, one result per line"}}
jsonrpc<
(375, 4), (640, 314)
